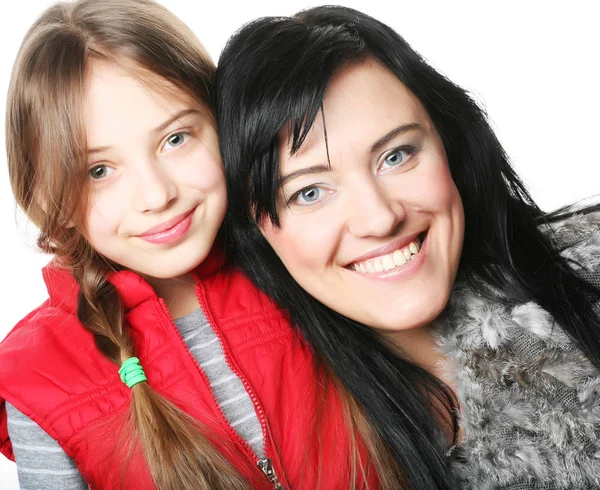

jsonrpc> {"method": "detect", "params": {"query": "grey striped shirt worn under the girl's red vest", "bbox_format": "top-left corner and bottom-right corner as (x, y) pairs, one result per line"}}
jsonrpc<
(6, 310), (264, 490)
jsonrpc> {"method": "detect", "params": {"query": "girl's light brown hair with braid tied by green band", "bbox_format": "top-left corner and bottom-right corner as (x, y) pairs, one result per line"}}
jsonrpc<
(6, 0), (250, 490)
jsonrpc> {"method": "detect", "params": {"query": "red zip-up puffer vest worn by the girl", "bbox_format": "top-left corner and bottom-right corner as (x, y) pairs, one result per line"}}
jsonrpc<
(0, 253), (377, 490)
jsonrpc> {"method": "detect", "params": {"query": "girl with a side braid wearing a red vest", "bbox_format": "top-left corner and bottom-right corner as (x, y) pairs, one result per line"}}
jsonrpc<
(0, 0), (384, 490)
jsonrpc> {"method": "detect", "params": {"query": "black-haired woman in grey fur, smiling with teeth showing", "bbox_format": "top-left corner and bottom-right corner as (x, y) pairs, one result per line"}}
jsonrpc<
(216, 7), (600, 490)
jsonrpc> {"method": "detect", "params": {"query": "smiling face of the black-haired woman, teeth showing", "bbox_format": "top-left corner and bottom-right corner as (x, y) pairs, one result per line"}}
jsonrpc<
(261, 60), (464, 331)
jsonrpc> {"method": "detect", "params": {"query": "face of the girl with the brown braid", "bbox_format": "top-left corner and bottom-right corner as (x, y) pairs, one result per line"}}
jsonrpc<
(84, 62), (227, 278)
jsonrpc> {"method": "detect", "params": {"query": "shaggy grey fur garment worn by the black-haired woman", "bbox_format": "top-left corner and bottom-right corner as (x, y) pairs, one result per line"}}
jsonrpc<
(434, 214), (600, 490)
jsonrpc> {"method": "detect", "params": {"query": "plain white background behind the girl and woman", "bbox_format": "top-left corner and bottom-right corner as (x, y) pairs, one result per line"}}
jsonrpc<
(0, 0), (600, 490)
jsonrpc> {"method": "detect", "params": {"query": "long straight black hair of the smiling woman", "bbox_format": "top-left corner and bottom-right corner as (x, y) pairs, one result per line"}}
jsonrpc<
(216, 7), (600, 490)
